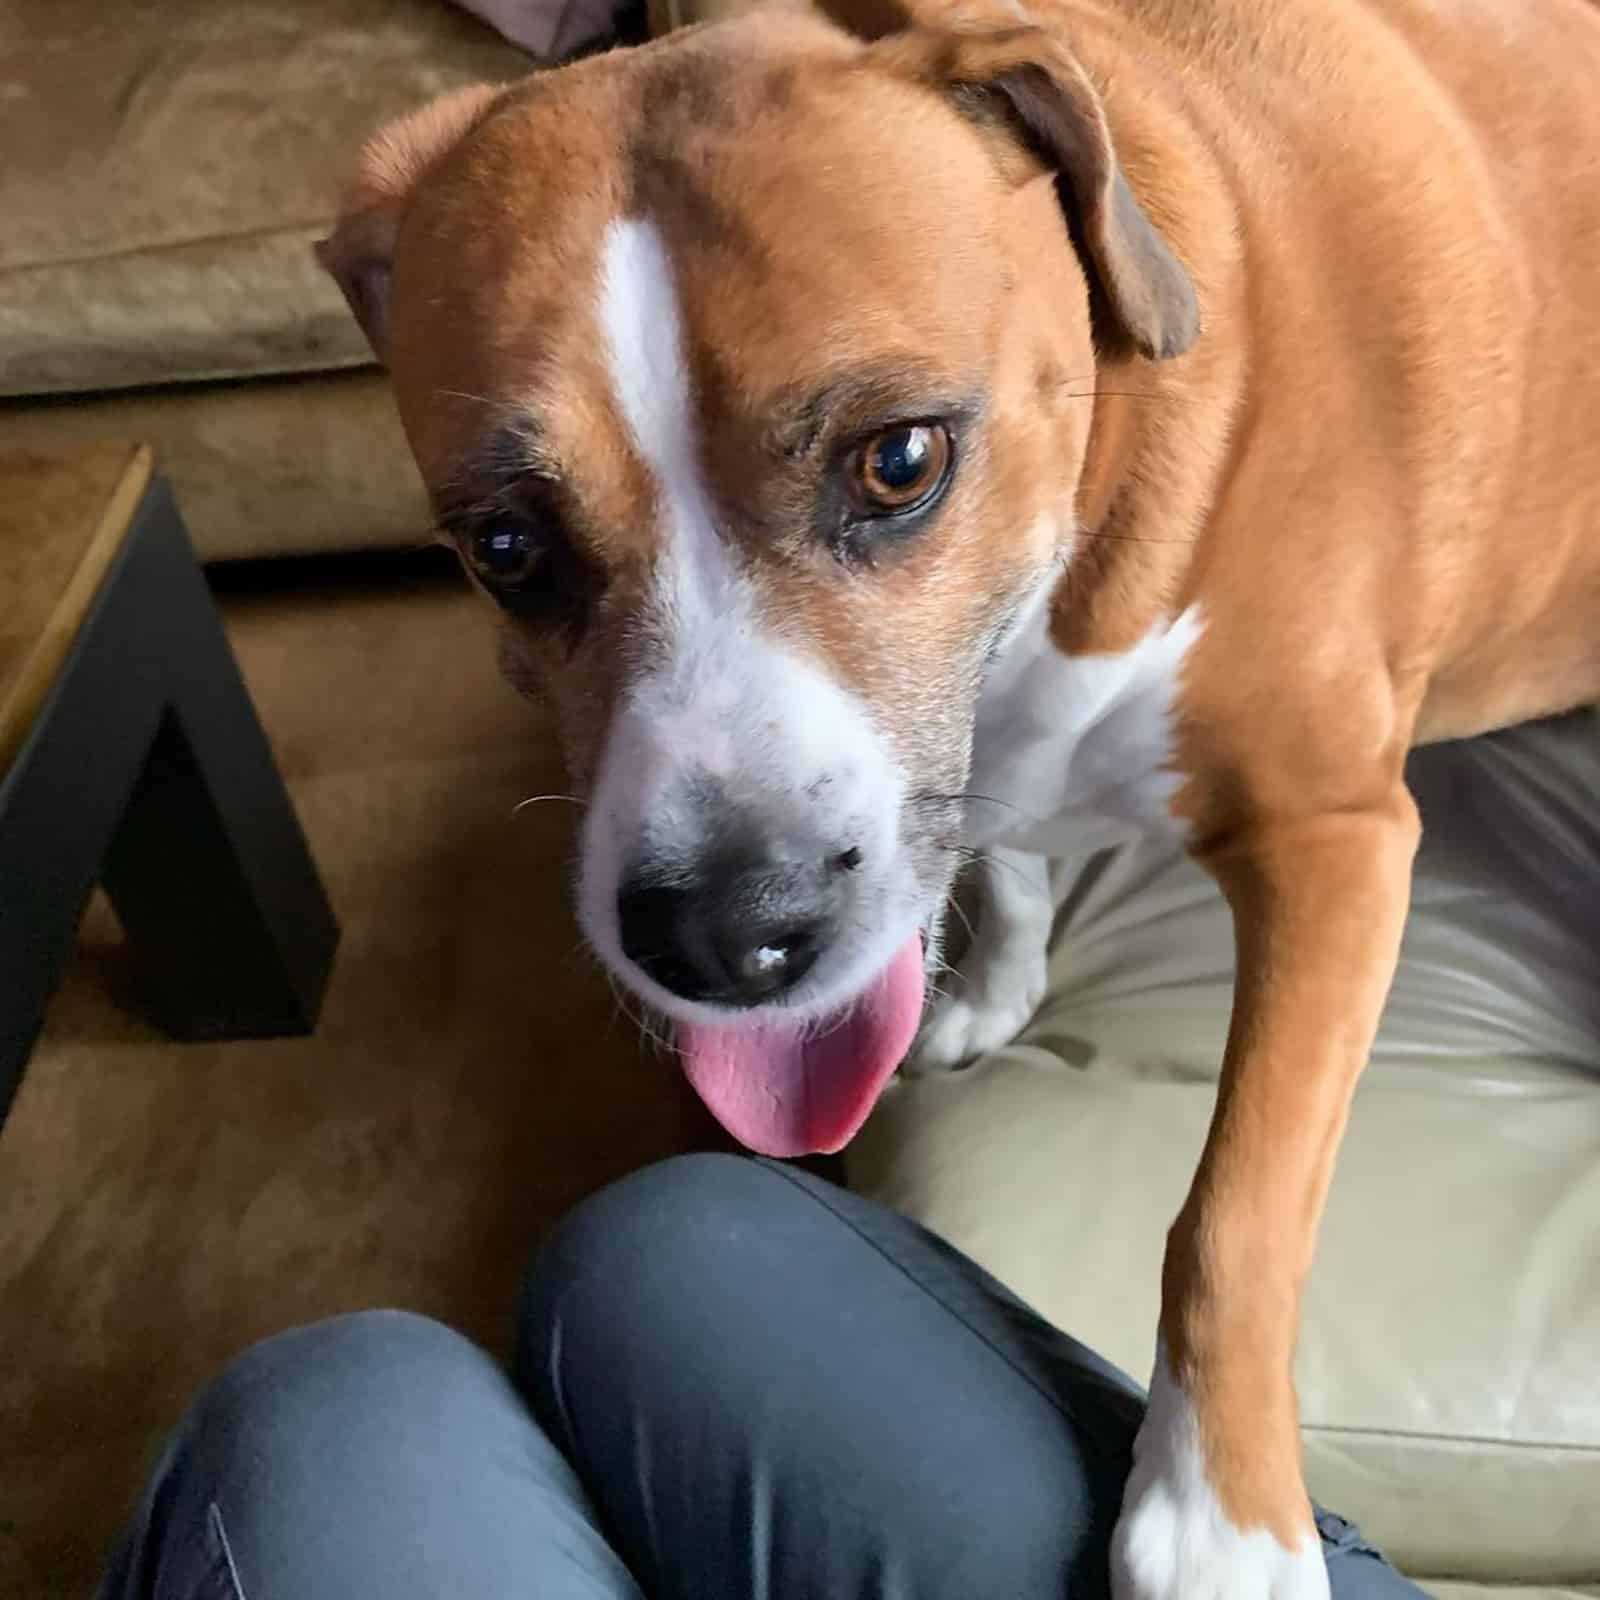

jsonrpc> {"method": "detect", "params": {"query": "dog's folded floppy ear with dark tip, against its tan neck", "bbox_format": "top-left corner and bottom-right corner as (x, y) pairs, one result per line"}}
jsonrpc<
(874, 27), (1200, 360)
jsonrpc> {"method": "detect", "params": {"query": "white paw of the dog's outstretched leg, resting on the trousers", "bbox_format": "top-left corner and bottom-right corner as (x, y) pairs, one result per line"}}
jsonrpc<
(1110, 1354), (1328, 1600)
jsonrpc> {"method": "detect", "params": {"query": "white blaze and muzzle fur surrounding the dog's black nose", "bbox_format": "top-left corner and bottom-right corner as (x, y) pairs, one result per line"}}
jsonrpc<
(579, 218), (909, 1011)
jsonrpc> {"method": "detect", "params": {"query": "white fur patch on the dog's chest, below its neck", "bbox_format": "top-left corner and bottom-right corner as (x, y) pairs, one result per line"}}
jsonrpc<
(968, 603), (1202, 854)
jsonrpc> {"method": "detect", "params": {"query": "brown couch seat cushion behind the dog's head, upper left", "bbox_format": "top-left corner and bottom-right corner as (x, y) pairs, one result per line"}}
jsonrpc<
(0, 0), (530, 395)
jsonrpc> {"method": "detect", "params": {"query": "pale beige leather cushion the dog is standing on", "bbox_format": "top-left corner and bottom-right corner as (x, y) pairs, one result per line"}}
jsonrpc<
(850, 714), (1600, 1594)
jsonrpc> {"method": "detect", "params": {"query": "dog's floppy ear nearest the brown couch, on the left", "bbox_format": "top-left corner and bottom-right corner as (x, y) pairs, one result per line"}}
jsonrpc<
(317, 83), (499, 362)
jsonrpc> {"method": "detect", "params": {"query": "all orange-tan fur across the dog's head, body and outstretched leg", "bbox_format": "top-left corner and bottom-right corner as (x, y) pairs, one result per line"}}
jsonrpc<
(318, 0), (1600, 1544)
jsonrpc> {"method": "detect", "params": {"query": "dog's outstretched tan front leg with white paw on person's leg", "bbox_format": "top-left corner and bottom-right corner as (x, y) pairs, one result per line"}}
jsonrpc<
(1114, 782), (1418, 1600)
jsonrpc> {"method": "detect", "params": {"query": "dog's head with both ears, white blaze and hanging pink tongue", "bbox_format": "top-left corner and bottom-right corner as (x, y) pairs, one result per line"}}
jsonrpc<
(323, 6), (1195, 1154)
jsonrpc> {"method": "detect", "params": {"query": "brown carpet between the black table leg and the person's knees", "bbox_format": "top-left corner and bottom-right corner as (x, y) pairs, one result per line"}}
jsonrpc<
(0, 560), (718, 1600)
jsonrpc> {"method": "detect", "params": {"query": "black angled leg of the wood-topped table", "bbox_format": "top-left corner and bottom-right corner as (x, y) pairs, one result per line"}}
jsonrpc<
(0, 480), (338, 1118)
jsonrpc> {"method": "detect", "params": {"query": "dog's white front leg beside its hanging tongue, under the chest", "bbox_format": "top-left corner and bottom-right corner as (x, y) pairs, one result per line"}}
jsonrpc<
(907, 848), (1051, 1074)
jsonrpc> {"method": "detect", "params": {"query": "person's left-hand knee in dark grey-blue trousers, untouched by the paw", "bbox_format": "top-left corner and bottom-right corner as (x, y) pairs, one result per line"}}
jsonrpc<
(121, 1312), (608, 1597)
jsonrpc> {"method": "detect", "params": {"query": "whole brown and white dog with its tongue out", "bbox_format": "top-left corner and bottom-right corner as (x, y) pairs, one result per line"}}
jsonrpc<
(323, 0), (1600, 1600)
